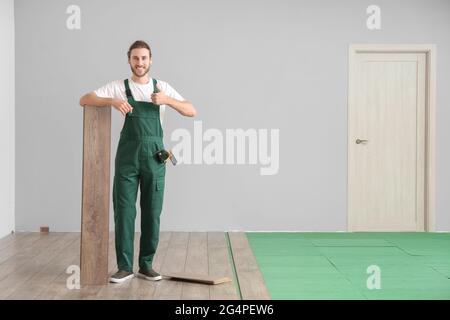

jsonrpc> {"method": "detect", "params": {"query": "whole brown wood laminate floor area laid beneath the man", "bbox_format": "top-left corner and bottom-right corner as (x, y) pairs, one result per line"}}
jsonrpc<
(0, 232), (270, 300)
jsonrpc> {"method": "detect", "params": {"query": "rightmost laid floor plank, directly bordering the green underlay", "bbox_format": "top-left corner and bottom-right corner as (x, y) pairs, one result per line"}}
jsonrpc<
(228, 232), (270, 300)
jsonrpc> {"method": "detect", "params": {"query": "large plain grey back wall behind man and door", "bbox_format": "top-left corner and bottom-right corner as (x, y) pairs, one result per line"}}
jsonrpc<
(15, 0), (450, 231)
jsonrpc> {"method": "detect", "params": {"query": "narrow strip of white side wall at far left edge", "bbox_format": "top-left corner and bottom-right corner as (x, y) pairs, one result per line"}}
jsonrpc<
(0, 0), (15, 238)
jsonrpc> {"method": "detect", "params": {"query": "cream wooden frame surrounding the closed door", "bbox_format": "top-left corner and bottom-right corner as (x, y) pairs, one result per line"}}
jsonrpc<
(347, 44), (436, 232)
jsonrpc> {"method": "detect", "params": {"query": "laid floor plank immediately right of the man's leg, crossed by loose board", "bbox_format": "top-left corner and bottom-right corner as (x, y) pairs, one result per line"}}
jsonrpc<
(153, 232), (189, 300)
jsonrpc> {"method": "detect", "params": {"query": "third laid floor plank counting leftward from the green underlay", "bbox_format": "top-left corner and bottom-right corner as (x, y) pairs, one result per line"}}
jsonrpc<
(181, 232), (209, 300)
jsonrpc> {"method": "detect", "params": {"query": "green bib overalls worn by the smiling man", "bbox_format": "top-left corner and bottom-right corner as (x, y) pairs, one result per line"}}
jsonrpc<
(113, 79), (166, 272)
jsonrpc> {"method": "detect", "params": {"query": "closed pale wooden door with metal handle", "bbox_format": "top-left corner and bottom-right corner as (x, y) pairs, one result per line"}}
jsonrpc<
(348, 52), (427, 231)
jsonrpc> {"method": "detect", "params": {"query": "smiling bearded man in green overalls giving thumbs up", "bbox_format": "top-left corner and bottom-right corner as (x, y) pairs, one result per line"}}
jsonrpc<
(80, 41), (196, 283)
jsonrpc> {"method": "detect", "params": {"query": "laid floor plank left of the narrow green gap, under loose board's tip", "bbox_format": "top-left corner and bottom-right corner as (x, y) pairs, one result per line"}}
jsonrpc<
(208, 232), (239, 300)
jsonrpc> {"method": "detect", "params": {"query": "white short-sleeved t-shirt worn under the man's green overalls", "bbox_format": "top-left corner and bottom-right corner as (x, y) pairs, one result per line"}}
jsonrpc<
(94, 78), (185, 126)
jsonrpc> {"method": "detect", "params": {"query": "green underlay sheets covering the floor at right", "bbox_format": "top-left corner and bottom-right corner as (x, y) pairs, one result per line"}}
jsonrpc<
(247, 232), (450, 300)
